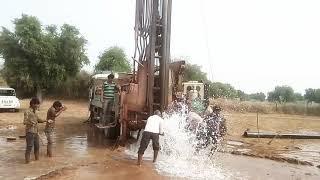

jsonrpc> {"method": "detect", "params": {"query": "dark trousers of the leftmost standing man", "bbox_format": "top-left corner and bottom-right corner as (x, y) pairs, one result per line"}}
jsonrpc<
(25, 132), (40, 163)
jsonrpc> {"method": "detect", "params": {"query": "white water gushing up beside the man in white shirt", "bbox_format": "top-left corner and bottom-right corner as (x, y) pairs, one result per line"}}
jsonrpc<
(127, 102), (231, 179)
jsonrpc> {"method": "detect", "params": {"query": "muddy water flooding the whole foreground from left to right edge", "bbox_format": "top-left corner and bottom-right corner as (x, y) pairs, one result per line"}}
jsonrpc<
(0, 123), (320, 180)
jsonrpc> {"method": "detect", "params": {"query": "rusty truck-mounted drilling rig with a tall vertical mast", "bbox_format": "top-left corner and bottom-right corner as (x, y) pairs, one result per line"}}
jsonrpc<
(89, 0), (185, 143)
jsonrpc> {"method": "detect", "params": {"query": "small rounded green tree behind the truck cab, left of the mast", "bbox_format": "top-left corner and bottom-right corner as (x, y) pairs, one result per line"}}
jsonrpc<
(95, 46), (131, 72)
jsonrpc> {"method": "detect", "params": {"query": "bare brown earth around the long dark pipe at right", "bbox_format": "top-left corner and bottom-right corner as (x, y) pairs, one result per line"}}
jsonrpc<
(225, 113), (320, 165)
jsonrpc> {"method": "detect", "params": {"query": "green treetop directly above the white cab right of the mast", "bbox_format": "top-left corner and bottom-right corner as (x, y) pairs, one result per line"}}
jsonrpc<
(183, 63), (208, 81)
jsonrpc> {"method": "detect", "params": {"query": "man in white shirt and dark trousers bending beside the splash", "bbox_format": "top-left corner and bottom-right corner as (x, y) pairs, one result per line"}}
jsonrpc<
(138, 110), (164, 166)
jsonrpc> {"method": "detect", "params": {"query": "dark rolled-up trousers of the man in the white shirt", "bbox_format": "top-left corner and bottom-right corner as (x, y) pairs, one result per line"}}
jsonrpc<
(138, 131), (160, 154)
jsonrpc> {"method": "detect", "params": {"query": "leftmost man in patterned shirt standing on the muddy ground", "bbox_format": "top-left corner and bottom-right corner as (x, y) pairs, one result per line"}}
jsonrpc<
(23, 98), (46, 164)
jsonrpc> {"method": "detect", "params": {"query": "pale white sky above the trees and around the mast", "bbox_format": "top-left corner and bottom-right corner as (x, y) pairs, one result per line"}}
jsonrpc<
(0, 0), (320, 93)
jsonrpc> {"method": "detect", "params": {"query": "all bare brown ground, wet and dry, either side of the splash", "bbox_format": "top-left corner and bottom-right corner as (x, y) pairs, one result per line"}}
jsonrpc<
(0, 100), (320, 180)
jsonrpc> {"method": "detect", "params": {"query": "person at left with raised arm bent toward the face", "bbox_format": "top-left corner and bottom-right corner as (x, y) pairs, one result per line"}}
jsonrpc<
(44, 101), (67, 157)
